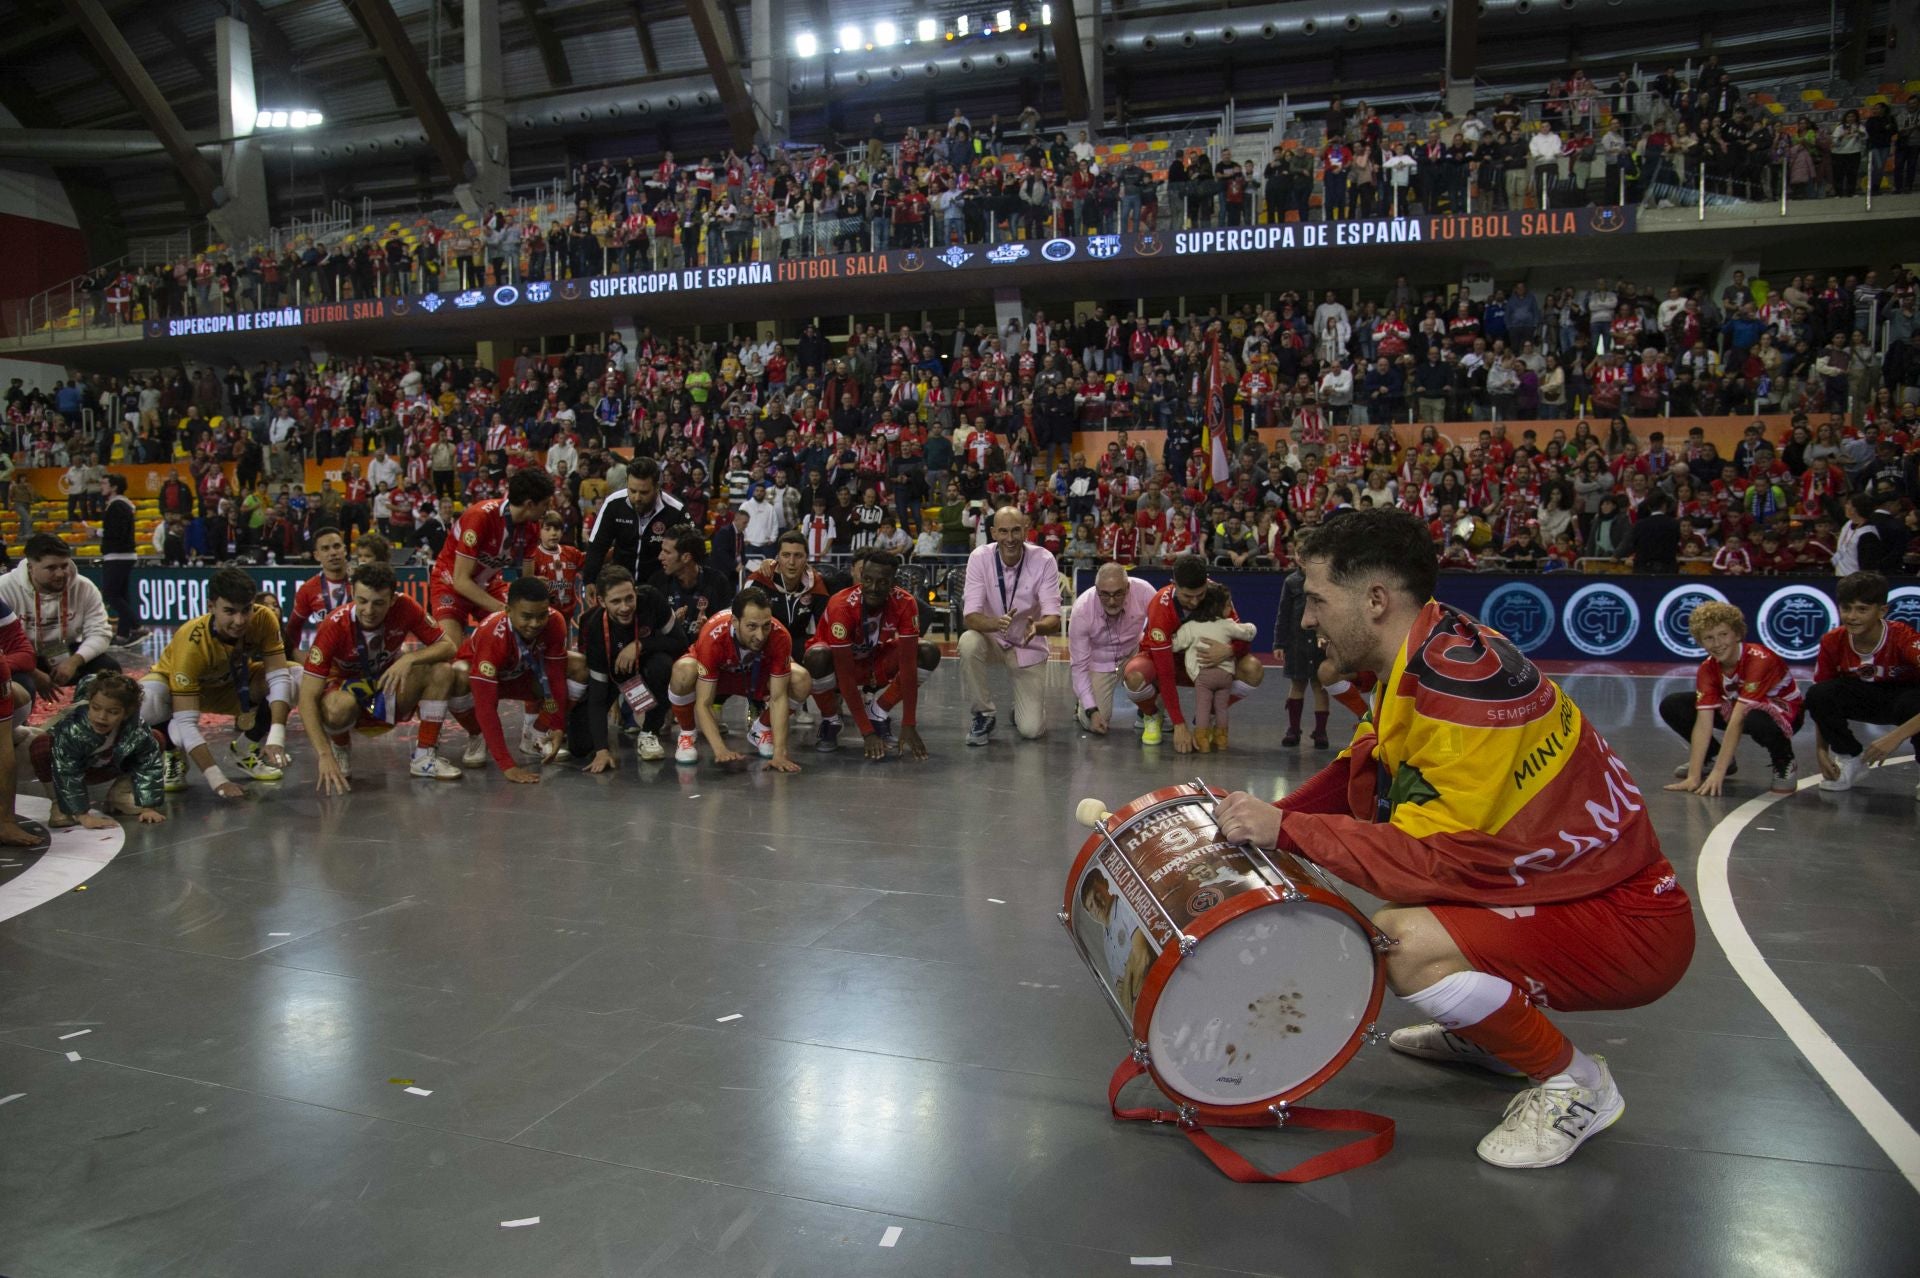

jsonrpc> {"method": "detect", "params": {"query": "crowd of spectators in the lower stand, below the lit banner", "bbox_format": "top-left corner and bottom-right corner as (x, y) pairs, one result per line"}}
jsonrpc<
(6, 272), (1920, 572)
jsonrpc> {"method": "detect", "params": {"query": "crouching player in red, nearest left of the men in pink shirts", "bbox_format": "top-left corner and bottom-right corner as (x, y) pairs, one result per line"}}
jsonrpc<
(804, 551), (941, 758)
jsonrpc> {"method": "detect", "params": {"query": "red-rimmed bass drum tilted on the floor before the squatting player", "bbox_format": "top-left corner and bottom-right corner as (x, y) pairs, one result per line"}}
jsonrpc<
(1060, 781), (1386, 1117)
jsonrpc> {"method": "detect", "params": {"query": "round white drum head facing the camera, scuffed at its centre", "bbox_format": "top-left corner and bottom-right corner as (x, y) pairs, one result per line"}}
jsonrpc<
(1146, 902), (1373, 1105)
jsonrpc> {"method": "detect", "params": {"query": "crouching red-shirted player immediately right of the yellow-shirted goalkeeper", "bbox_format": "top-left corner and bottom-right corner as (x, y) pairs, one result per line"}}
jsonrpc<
(300, 564), (461, 794)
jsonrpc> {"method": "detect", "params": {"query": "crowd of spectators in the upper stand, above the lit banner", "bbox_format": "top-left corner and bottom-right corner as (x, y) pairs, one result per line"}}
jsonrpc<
(60, 58), (1920, 322)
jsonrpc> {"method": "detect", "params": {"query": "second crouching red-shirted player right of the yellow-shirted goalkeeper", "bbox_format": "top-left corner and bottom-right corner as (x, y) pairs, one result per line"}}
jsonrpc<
(432, 578), (588, 785)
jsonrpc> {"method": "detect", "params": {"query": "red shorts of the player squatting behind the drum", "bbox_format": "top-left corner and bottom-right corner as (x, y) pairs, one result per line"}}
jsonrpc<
(1427, 856), (1693, 1011)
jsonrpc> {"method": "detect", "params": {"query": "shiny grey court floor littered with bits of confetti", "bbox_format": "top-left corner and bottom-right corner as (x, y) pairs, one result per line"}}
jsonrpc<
(0, 666), (1920, 1278)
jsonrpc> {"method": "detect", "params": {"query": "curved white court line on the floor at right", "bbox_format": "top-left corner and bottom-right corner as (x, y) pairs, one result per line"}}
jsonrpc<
(1699, 756), (1920, 1190)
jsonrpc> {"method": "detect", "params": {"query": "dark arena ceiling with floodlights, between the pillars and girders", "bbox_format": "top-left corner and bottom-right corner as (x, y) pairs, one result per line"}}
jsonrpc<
(0, 0), (1885, 253)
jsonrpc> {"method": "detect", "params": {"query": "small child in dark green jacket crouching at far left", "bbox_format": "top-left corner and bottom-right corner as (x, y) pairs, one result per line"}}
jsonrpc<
(27, 674), (167, 829)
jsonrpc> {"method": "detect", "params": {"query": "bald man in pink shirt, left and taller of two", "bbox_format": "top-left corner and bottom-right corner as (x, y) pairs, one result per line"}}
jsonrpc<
(960, 507), (1060, 746)
